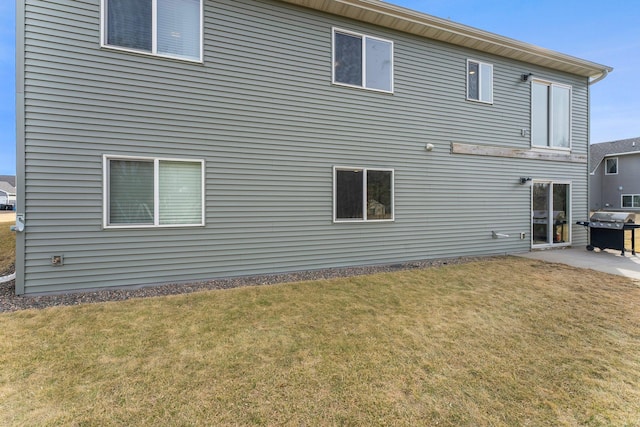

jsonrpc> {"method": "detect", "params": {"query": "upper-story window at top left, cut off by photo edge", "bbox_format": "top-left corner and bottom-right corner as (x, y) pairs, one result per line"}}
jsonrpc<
(102, 0), (202, 61)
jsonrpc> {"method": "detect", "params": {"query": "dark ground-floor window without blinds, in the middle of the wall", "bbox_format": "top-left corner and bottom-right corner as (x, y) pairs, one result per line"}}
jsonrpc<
(333, 167), (394, 221)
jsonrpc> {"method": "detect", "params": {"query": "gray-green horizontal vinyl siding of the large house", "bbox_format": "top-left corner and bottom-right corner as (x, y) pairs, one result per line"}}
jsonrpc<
(19, 0), (588, 293)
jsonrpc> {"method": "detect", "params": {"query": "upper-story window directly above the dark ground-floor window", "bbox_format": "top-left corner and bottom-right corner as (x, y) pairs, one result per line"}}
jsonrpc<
(333, 29), (393, 92)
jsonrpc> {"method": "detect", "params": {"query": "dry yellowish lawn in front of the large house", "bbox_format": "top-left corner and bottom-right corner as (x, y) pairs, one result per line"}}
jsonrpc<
(0, 257), (640, 426)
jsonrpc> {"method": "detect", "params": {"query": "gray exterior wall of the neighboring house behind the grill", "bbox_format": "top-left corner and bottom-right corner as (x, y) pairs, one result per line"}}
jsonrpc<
(590, 152), (640, 212)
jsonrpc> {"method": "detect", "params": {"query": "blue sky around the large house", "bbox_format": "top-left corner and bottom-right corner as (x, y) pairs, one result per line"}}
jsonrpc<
(0, 0), (640, 175)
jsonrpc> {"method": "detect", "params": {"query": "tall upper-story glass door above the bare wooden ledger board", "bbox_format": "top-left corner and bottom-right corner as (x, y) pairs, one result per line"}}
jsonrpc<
(531, 81), (571, 148)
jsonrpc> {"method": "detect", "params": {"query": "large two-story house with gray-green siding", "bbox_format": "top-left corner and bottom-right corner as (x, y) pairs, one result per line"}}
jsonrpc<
(16, 0), (611, 294)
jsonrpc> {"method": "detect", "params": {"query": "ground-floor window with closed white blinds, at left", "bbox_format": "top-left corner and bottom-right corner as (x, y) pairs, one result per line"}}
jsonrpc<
(104, 156), (204, 227)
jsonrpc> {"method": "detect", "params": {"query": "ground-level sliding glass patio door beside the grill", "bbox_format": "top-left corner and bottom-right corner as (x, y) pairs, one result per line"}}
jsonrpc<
(531, 181), (571, 247)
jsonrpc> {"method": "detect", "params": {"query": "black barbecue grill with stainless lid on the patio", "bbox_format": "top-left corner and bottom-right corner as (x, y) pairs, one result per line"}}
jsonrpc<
(576, 212), (640, 255)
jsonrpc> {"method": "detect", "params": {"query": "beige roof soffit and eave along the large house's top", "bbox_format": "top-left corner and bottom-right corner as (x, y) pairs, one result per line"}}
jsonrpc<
(280, 0), (613, 77)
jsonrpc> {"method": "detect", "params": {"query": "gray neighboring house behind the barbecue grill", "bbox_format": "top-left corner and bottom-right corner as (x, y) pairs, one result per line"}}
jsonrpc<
(589, 138), (640, 212)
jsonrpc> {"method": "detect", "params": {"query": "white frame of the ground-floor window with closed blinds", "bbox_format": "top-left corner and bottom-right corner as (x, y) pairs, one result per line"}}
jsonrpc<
(102, 154), (205, 229)
